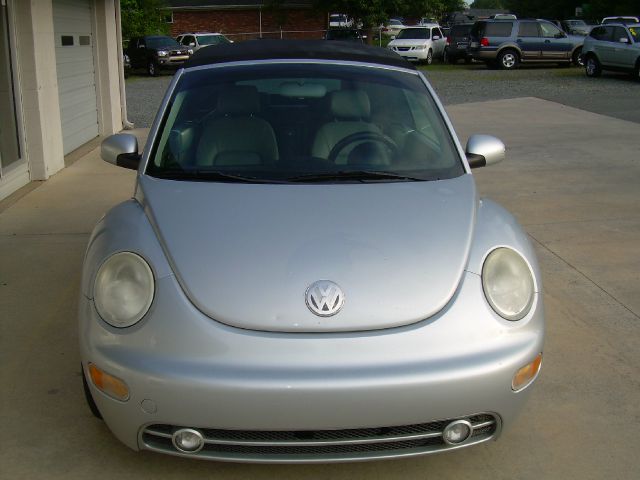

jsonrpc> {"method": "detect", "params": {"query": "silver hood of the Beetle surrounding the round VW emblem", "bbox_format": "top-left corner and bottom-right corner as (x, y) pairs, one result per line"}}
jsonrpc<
(137, 175), (477, 332)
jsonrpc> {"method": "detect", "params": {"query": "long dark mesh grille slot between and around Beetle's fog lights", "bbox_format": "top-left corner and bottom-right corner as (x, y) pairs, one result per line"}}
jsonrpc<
(140, 414), (498, 462)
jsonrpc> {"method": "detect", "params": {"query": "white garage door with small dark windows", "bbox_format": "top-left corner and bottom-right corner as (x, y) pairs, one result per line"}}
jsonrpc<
(53, 0), (98, 155)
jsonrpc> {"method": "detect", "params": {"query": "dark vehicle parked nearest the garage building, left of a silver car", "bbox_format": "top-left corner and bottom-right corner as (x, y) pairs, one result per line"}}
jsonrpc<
(126, 35), (193, 77)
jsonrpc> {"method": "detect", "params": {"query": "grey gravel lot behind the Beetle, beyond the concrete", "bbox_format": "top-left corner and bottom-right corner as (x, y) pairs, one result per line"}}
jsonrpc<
(127, 64), (640, 127)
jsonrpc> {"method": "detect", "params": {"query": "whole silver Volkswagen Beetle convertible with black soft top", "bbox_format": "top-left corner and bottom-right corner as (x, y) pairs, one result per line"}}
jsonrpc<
(79, 41), (544, 462)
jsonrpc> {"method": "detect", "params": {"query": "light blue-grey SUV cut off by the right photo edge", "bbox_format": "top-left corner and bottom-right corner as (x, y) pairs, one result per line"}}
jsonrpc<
(583, 23), (640, 80)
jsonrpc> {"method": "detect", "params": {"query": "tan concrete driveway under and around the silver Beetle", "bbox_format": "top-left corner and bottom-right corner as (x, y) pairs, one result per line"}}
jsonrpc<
(0, 98), (640, 480)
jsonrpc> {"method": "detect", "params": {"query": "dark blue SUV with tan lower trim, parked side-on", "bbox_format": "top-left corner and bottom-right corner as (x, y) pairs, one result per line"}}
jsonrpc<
(469, 20), (584, 70)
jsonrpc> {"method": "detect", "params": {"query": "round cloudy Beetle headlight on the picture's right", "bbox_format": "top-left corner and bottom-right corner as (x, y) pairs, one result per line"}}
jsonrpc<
(482, 248), (534, 320)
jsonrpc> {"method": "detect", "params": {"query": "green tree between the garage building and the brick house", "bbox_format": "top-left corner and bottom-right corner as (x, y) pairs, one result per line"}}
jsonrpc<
(120, 0), (169, 40)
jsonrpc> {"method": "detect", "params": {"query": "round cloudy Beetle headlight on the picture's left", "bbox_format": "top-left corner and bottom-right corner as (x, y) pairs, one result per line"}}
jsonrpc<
(93, 252), (155, 328)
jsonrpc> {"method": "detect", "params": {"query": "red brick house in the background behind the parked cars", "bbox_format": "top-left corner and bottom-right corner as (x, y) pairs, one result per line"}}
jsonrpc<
(167, 0), (328, 40)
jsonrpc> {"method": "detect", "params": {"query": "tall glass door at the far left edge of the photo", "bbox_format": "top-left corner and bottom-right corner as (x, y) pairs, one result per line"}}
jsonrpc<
(0, 0), (22, 177)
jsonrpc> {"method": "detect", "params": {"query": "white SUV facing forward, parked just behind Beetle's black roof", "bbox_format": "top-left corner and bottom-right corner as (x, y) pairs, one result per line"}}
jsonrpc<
(387, 24), (446, 65)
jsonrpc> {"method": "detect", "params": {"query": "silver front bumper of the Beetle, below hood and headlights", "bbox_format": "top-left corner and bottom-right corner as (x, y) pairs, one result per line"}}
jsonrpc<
(80, 273), (544, 462)
